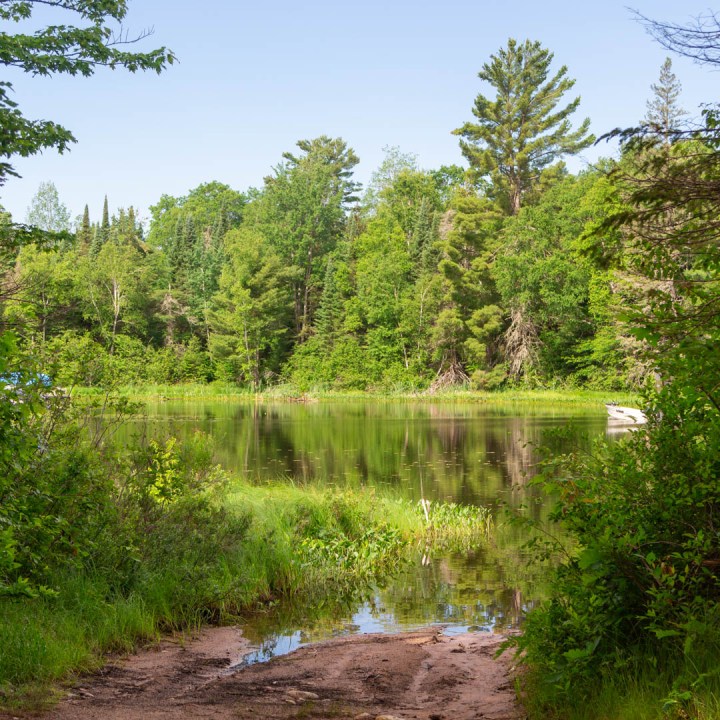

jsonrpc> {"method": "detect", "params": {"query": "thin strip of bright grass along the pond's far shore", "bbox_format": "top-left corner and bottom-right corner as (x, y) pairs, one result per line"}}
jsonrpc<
(73, 383), (639, 405)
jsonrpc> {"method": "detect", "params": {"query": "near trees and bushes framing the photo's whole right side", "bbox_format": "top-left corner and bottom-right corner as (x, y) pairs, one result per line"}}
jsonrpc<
(518, 16), (720, 718)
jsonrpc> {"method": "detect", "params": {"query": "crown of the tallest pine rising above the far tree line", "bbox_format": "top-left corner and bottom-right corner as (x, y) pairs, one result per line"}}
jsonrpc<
(453, 39), (594, 215)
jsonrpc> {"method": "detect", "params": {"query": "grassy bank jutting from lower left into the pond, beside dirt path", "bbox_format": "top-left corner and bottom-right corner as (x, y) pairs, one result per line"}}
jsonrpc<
(0, 470), (489, 707)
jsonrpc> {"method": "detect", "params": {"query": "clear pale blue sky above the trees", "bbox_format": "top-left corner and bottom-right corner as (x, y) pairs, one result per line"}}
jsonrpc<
(0, 0), (720, 221)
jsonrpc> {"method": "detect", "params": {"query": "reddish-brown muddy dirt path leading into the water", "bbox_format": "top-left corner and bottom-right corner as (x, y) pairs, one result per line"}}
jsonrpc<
(4, 628), (524, 720)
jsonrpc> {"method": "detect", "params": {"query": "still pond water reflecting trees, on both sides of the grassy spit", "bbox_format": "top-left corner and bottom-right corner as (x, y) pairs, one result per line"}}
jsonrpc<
(124, 400), (607, 662)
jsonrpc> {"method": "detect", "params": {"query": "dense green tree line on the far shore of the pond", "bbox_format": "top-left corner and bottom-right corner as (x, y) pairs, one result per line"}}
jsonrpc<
(2, 40), (681, 389)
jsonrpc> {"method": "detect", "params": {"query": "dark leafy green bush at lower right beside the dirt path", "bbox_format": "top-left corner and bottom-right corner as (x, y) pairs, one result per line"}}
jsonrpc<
(515, 385), (720, 704)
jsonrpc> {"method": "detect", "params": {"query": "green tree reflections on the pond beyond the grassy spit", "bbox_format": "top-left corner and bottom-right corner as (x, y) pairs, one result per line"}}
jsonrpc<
(124, 401), (607, 505)
